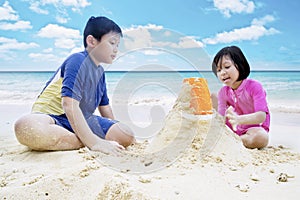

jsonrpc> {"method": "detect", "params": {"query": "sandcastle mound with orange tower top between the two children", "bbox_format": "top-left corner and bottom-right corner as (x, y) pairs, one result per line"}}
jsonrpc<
(96, 78), (249, 173)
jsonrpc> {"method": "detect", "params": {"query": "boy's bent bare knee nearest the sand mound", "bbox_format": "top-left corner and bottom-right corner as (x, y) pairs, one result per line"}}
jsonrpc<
(105, 122), (135, 147)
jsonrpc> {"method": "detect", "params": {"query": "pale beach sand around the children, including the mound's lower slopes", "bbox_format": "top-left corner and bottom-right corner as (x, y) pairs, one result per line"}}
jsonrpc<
(0, 88), (300, 200)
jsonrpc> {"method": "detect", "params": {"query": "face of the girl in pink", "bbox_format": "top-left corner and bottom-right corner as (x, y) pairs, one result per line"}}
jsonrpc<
(217, 55), (241, 89)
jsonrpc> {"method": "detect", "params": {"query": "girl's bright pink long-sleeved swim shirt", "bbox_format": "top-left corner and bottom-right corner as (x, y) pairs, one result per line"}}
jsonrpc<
(218, 79), (270, 135)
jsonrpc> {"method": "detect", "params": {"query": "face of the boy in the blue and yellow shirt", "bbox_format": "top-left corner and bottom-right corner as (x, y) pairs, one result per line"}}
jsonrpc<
(91, 32), (120, 65)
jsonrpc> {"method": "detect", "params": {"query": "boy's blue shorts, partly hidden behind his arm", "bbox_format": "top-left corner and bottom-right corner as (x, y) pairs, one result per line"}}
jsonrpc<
(49, 114), (118, 139)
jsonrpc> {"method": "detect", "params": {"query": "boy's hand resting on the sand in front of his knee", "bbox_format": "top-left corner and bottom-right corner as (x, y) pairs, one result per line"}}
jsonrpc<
(91, 140), (125, 155)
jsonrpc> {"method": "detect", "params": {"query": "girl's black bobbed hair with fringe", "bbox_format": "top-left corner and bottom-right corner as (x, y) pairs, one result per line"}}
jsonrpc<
(211, 46), (250, 81)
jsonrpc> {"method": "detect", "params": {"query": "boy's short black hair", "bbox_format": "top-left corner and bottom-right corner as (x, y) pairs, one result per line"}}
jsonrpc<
(83, 16), (122, 48)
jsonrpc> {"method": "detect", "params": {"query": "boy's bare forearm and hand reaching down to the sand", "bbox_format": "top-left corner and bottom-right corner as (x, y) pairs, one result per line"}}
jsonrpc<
(62, 97), (124, 154)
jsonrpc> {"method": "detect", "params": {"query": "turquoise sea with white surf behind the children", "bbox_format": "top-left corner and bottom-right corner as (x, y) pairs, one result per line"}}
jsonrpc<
(0, 71), (300, 110)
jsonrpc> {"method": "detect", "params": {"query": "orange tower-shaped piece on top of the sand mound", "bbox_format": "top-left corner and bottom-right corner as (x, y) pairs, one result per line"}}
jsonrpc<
(183, 78), (213, 115)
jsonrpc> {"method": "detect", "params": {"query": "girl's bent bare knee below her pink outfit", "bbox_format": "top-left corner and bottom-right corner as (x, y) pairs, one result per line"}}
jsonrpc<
(241, 127), (269, 149)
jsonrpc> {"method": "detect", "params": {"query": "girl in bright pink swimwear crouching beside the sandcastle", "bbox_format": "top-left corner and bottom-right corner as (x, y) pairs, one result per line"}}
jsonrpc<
(212, 46), (270, 148)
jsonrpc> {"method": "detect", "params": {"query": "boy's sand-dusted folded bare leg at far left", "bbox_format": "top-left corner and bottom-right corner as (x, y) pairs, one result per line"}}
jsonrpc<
(14, 114), (83, 151)
